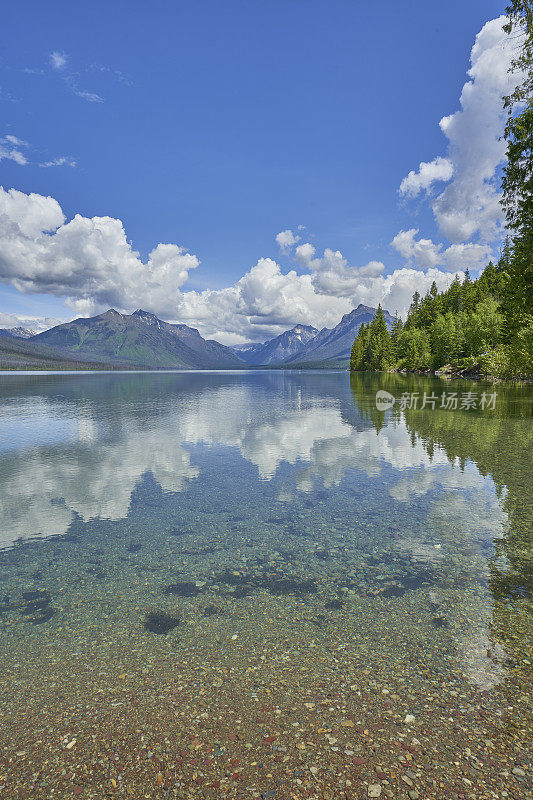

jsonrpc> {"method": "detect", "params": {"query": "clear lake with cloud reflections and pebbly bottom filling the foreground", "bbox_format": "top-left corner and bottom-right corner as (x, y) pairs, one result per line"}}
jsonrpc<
(0, 372), (533, 798)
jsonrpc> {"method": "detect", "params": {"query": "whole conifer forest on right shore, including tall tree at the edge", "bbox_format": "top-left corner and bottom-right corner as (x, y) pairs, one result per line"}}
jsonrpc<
(350, 0), (533, 377)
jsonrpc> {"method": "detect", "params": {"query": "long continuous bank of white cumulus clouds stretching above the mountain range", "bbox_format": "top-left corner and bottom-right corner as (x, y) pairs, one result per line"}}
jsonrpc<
(0, 188), (472, 344)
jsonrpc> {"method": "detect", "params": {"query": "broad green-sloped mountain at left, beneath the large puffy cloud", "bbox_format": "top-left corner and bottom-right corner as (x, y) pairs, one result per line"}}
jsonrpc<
(31, 308), (243, 369)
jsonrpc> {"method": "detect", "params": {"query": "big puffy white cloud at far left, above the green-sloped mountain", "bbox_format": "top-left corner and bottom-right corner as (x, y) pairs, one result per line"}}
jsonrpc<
(0, 188), (199, 309)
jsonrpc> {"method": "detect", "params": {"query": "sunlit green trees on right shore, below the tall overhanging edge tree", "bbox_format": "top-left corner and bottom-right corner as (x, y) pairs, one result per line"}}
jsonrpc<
(350, 262), (533, 378)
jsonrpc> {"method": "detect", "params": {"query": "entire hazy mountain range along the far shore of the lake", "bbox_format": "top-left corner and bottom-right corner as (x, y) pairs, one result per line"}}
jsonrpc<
(0, 304), (393, 369)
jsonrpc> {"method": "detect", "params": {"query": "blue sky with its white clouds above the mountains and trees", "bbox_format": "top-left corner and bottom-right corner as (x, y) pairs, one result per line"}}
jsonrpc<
(0, 0), (503, 340)
